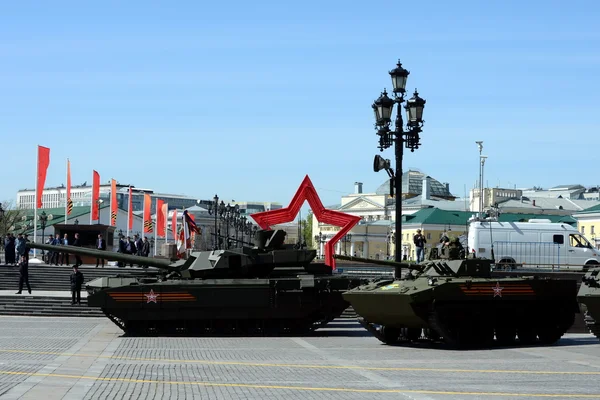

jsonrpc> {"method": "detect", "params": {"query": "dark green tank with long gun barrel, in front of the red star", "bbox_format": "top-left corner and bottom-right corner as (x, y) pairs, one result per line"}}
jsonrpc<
(31, 230), (366, 336)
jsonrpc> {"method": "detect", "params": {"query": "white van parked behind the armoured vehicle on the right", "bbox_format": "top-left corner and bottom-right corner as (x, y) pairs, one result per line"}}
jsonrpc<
(468, 219), (600, 269)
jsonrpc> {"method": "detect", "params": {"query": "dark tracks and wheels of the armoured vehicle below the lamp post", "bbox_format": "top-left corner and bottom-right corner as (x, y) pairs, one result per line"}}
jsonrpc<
(358, 304), (576, 349)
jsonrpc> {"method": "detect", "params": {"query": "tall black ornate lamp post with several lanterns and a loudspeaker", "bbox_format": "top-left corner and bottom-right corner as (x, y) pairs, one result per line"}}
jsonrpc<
(372, 61), (425, 262)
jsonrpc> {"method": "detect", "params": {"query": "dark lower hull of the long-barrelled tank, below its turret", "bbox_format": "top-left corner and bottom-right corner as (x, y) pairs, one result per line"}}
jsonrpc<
(87, 276), (364, 336)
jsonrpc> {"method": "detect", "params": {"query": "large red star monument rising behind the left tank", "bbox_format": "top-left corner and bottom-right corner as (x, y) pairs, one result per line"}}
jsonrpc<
(250, 175), (360, 269)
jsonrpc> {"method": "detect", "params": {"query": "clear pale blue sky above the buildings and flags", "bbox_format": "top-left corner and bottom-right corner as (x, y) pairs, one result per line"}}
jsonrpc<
(0, 0), (600, 211)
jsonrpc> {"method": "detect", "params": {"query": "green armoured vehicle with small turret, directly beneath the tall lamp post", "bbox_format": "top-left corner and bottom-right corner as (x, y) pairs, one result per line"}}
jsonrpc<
(336, 244), (580, 347)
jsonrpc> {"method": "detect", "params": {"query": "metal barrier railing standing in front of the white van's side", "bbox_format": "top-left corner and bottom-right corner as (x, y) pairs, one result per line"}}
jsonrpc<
(494, 241), (568, 269)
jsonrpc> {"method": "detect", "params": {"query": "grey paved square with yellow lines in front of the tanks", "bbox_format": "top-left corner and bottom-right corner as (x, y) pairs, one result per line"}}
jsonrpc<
(0, 316), (600, 400)
